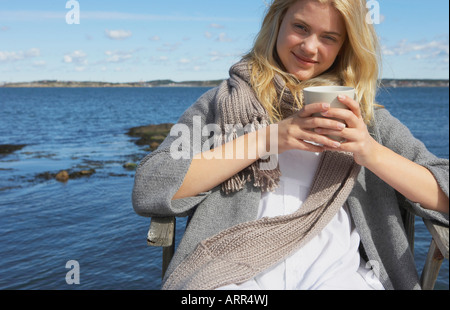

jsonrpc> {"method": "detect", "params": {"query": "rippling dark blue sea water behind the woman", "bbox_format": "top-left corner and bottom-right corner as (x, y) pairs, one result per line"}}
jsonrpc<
(0, 88), (449, 290)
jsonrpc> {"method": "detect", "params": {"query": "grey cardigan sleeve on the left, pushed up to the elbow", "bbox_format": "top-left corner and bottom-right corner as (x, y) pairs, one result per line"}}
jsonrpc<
(132, 89), (220, 217)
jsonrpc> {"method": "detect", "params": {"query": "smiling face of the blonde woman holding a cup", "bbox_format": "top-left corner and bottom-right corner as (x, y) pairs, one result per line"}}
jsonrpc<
(277, 0), (347, 81)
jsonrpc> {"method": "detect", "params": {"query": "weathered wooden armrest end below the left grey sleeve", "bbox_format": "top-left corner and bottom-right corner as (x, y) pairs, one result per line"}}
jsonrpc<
(147, 217), (175, 247)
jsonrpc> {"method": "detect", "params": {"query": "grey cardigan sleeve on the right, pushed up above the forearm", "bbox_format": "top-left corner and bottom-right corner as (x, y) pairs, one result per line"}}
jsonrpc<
(375, 109), (449, 226)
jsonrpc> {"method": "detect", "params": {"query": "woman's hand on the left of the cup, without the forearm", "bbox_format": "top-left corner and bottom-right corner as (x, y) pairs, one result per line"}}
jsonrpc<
(271, 103), (346, 154)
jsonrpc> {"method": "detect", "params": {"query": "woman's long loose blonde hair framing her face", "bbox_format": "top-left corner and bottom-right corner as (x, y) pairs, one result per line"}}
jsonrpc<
(244, 0), (381, 123)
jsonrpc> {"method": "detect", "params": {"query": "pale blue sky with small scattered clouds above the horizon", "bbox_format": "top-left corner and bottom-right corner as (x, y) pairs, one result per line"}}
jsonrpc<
(0, 0), (449, 83)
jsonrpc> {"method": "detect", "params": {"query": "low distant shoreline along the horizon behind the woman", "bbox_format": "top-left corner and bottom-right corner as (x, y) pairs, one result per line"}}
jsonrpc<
(0, 79), (449, 88)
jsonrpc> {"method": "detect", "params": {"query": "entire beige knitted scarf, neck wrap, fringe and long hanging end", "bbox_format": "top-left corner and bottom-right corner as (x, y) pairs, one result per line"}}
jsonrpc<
(163, 63), (360, 289)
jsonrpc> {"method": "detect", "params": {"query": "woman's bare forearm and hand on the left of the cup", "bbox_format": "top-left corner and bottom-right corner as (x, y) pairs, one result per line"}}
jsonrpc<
(173, 103), (343, 200)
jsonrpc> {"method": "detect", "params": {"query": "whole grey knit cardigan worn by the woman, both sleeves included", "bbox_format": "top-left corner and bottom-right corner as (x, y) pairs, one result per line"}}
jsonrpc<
(132, 88), (449, 290)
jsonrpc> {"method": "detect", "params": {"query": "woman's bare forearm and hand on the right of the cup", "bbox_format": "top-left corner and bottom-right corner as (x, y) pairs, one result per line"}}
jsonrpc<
(315, 97), (449, 214)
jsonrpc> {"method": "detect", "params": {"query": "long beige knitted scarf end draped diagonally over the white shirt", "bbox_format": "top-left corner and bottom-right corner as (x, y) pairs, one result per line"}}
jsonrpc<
(163, 152), (360, 290)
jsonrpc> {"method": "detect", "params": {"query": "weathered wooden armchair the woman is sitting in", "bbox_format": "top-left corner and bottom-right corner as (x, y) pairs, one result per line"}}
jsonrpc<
(147, 212), (448, 290)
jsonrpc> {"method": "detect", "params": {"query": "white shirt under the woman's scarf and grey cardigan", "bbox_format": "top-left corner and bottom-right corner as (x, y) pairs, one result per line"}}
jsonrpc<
(219, 150), (384, 290)
